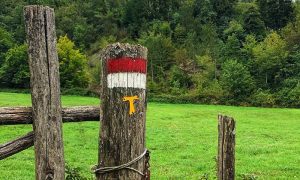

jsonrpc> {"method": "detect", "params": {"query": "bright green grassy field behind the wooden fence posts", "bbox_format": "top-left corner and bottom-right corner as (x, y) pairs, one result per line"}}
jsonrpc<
(0, 93), (300, 180)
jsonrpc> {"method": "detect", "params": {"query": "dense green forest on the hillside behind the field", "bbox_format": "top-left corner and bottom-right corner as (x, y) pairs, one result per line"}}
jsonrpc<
(0, 0), (300, 107)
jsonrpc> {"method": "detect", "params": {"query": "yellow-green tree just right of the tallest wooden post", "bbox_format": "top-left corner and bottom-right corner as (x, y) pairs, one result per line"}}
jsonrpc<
(57, 36), (90, 88)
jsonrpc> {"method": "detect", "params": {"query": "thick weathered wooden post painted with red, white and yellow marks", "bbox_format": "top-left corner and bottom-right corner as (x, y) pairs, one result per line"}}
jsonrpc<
(95, 43), (150, 180)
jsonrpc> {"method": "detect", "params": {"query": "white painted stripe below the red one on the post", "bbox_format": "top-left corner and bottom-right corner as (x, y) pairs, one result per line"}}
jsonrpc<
(107, 73), (146, 89)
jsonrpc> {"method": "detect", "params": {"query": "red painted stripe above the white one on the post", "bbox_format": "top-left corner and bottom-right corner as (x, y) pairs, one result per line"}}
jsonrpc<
(107, 57), (147, 73)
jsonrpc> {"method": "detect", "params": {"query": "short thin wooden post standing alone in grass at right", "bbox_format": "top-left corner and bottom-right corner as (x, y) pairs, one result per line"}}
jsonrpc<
(218, 115), (235, 180)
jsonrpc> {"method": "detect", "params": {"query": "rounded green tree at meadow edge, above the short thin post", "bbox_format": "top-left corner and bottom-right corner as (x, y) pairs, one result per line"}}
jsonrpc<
(220, 60), (255, 103)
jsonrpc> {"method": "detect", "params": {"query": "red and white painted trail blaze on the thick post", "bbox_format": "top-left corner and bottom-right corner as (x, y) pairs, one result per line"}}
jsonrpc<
(107, 57), (147, 89)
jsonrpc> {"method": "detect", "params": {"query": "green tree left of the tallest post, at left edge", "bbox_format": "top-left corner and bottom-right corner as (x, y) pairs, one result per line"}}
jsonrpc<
(0, 45), (30, 88)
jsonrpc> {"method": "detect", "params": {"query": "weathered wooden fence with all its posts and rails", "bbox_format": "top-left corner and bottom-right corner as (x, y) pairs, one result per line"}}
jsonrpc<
(0, 6), (235, 180)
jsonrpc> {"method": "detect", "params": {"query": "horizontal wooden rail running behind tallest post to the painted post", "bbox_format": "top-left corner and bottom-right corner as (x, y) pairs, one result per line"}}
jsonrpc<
(0, 106), (100, 125)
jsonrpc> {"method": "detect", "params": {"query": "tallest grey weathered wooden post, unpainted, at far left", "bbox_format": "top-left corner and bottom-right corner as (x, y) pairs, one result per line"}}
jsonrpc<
(24, 6), (65, 180)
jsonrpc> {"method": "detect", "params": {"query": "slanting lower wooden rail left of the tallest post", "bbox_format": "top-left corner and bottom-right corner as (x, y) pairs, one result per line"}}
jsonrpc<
(0, 131), (34, 160)
